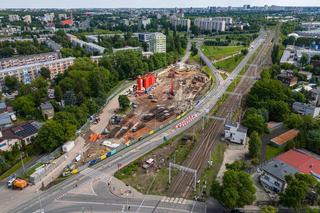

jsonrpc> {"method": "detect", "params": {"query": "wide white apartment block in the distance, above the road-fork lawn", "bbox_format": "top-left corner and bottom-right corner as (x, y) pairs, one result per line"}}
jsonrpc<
(194, 18), (226, 32)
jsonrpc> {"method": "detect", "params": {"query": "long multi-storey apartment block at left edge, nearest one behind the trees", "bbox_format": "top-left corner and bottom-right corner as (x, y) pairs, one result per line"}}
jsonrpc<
(0, 57), (75, 86)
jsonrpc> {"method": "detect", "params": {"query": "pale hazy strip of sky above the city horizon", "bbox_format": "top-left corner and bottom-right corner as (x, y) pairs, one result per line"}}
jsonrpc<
(0, 0), (320, 8)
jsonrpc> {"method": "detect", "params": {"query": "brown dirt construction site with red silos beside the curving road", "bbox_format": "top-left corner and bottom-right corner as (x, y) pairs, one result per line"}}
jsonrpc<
(82, 63), (211, 162)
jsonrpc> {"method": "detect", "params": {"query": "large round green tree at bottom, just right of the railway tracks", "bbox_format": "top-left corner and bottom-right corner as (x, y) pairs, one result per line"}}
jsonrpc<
(211, 170), (256, 208)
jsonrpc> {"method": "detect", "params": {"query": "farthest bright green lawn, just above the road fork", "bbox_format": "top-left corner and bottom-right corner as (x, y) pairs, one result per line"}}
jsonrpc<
(201, 45), (244, 60)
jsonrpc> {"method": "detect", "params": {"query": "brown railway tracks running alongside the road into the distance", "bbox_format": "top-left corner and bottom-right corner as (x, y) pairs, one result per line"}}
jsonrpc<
(168, 29), (275, 198)
